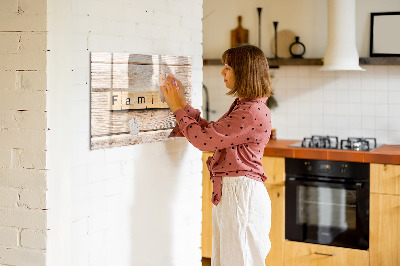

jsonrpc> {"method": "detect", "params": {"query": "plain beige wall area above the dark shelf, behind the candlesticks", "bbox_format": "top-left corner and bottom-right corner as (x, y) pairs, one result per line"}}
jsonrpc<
(203, 0), (400, 59)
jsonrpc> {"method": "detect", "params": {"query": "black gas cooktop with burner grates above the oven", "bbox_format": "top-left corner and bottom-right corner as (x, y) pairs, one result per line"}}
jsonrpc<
(289, 135), (382, 151)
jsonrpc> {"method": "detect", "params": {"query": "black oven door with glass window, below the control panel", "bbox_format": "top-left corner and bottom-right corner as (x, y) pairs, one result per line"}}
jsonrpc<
(285, 176), (369, 250)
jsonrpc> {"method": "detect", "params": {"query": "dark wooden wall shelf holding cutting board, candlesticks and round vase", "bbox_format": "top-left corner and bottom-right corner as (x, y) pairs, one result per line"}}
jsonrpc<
(203, 57), (400, 68)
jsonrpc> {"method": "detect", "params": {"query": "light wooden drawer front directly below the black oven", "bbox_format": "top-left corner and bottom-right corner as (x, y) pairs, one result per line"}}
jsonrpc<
(284, 240), (369, 266)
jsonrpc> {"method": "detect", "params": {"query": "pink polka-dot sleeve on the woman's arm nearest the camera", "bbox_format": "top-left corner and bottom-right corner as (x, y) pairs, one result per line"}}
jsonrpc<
(174, 105), (255, 151)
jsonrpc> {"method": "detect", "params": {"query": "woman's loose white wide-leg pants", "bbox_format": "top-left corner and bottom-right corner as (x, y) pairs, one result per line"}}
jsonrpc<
(211, 176), (271, 266)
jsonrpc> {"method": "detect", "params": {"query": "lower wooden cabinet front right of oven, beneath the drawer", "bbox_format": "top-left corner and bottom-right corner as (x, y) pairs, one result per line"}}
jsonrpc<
(369, 194), (400, 266)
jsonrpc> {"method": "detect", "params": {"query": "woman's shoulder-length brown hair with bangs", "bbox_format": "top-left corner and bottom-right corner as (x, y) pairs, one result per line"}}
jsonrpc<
(222, 44), (274, 99)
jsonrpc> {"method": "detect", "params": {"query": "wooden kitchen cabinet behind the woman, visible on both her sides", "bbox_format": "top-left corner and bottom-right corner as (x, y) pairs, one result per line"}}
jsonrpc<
(201, 152), (285, 266)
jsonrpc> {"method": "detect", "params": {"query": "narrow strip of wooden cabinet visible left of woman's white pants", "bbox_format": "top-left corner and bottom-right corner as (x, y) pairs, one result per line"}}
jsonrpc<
(201, 152), (213, 258)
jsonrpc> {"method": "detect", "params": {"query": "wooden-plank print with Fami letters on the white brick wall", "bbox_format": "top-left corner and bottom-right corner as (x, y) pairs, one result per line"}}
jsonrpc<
(90, 53), (192, 149)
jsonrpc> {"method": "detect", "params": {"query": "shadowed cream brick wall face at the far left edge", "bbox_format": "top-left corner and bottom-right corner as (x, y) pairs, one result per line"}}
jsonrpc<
(0, 0), (47, 265)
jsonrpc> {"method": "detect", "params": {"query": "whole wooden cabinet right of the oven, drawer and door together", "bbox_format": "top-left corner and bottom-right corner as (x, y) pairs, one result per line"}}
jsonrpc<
(369, 164), (400, 266)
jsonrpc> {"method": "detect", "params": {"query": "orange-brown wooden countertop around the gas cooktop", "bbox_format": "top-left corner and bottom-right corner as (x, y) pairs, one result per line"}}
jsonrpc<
(264, 139), (400, 164)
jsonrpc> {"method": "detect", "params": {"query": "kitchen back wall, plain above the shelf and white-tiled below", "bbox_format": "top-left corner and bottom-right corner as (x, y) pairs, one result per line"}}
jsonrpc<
(203, 0), (400, 144)
